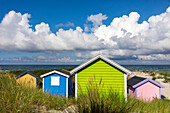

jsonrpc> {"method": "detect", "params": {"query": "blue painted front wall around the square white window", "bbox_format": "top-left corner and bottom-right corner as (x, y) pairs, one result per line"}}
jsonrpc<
(44, 73), (67, 96)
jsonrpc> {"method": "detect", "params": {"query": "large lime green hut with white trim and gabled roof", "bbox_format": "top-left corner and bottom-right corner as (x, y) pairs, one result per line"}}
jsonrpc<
(70, 55), (131, 98)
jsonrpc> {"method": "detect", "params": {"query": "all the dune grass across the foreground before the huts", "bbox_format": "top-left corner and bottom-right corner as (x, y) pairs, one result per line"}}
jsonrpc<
(0, 73), (170, 113)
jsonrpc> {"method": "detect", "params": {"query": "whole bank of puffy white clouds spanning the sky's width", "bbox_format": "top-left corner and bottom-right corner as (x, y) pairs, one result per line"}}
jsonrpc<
(0, 7), (170, 61)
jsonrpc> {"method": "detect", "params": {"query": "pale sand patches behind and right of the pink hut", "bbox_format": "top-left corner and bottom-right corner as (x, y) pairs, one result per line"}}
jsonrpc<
(131, 72), (170, 99)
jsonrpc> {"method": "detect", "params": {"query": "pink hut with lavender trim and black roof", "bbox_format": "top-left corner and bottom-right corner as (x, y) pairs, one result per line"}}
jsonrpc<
(127, 76), (164, 101)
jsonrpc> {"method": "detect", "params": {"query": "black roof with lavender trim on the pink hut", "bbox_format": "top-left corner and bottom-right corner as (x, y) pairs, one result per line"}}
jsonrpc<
(127, 76), (165, 88)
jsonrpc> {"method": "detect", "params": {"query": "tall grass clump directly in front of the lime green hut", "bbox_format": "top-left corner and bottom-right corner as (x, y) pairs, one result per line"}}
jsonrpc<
(77, 79), (136, 113)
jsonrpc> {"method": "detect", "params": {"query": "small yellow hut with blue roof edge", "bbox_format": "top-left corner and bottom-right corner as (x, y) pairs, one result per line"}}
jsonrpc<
(15, 71), (38, 87)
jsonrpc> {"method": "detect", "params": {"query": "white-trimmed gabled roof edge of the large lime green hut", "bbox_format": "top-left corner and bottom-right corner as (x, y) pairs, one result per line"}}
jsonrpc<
(70, 55), (131, 75)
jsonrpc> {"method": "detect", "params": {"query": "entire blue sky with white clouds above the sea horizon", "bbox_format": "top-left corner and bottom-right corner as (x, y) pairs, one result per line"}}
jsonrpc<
(0, 0), (170, 64)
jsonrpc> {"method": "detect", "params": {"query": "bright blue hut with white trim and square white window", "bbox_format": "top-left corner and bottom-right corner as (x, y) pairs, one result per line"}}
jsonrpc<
(40, 70), (73, 97)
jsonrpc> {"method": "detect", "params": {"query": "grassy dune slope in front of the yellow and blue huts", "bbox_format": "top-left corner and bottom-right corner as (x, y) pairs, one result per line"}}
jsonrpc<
(0, 73), (74, 112)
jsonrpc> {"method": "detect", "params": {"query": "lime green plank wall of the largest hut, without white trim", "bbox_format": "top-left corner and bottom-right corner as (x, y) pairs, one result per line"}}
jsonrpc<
(77, 60), (125, 95)
